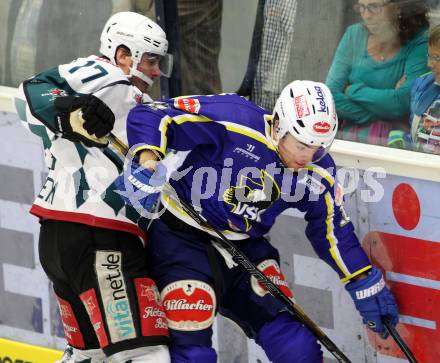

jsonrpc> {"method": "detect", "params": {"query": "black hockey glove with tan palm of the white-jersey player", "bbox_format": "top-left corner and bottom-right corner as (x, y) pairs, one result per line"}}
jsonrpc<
(54, 95), (115, 147)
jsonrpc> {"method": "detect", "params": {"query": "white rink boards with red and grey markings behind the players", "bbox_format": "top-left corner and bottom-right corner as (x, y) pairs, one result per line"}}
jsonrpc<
(0, 90), (440, 363)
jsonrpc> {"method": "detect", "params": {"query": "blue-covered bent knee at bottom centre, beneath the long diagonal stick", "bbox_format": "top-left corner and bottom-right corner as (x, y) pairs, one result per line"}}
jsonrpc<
(256, 313), (323, 363)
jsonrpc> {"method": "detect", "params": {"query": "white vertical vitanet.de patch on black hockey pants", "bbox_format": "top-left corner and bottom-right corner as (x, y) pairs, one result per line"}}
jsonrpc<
(95, 251), (136, 343)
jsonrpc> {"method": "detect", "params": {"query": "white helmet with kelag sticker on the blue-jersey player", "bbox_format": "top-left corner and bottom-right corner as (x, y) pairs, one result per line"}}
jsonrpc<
(273, 81), (338, 161)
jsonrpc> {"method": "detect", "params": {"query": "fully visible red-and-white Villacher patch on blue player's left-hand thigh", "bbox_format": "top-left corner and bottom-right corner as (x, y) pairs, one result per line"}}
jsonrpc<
(161, 280), (216, 331)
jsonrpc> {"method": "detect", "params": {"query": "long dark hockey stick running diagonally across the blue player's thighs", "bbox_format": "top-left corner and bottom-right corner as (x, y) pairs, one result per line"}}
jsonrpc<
(107, 133), (351, 363)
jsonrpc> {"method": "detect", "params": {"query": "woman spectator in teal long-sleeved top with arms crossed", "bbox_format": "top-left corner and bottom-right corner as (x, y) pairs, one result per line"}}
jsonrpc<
(326, 0), (429, 145)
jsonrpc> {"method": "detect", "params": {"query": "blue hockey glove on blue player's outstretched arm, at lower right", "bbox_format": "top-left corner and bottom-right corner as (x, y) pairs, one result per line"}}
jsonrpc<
(345, 266), (399, 338)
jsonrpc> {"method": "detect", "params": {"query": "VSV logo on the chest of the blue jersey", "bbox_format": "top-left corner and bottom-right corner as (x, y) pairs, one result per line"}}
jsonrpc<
(223, 170), (281, 232)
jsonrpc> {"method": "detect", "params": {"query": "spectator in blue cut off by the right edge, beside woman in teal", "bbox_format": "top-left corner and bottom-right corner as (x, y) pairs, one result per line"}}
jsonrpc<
(411, 25), (440, 154)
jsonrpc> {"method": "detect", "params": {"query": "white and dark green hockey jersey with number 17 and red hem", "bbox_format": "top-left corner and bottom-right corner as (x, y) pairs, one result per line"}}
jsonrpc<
(15, 55), (151, 242)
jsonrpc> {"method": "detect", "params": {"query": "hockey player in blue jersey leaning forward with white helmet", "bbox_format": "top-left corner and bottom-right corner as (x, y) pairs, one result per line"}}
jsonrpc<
(116, 81), (398, 363)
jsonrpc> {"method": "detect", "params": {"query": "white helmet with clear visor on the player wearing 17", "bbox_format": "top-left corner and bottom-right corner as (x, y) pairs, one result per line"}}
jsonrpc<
(99, 11), (173, 85)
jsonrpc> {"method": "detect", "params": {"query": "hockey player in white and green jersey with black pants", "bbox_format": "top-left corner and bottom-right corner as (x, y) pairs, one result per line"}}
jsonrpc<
(15, 12), (172, 363)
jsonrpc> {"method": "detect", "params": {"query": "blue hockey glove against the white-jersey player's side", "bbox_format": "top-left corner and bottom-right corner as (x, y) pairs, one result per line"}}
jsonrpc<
(115, 160), (167, 214)
